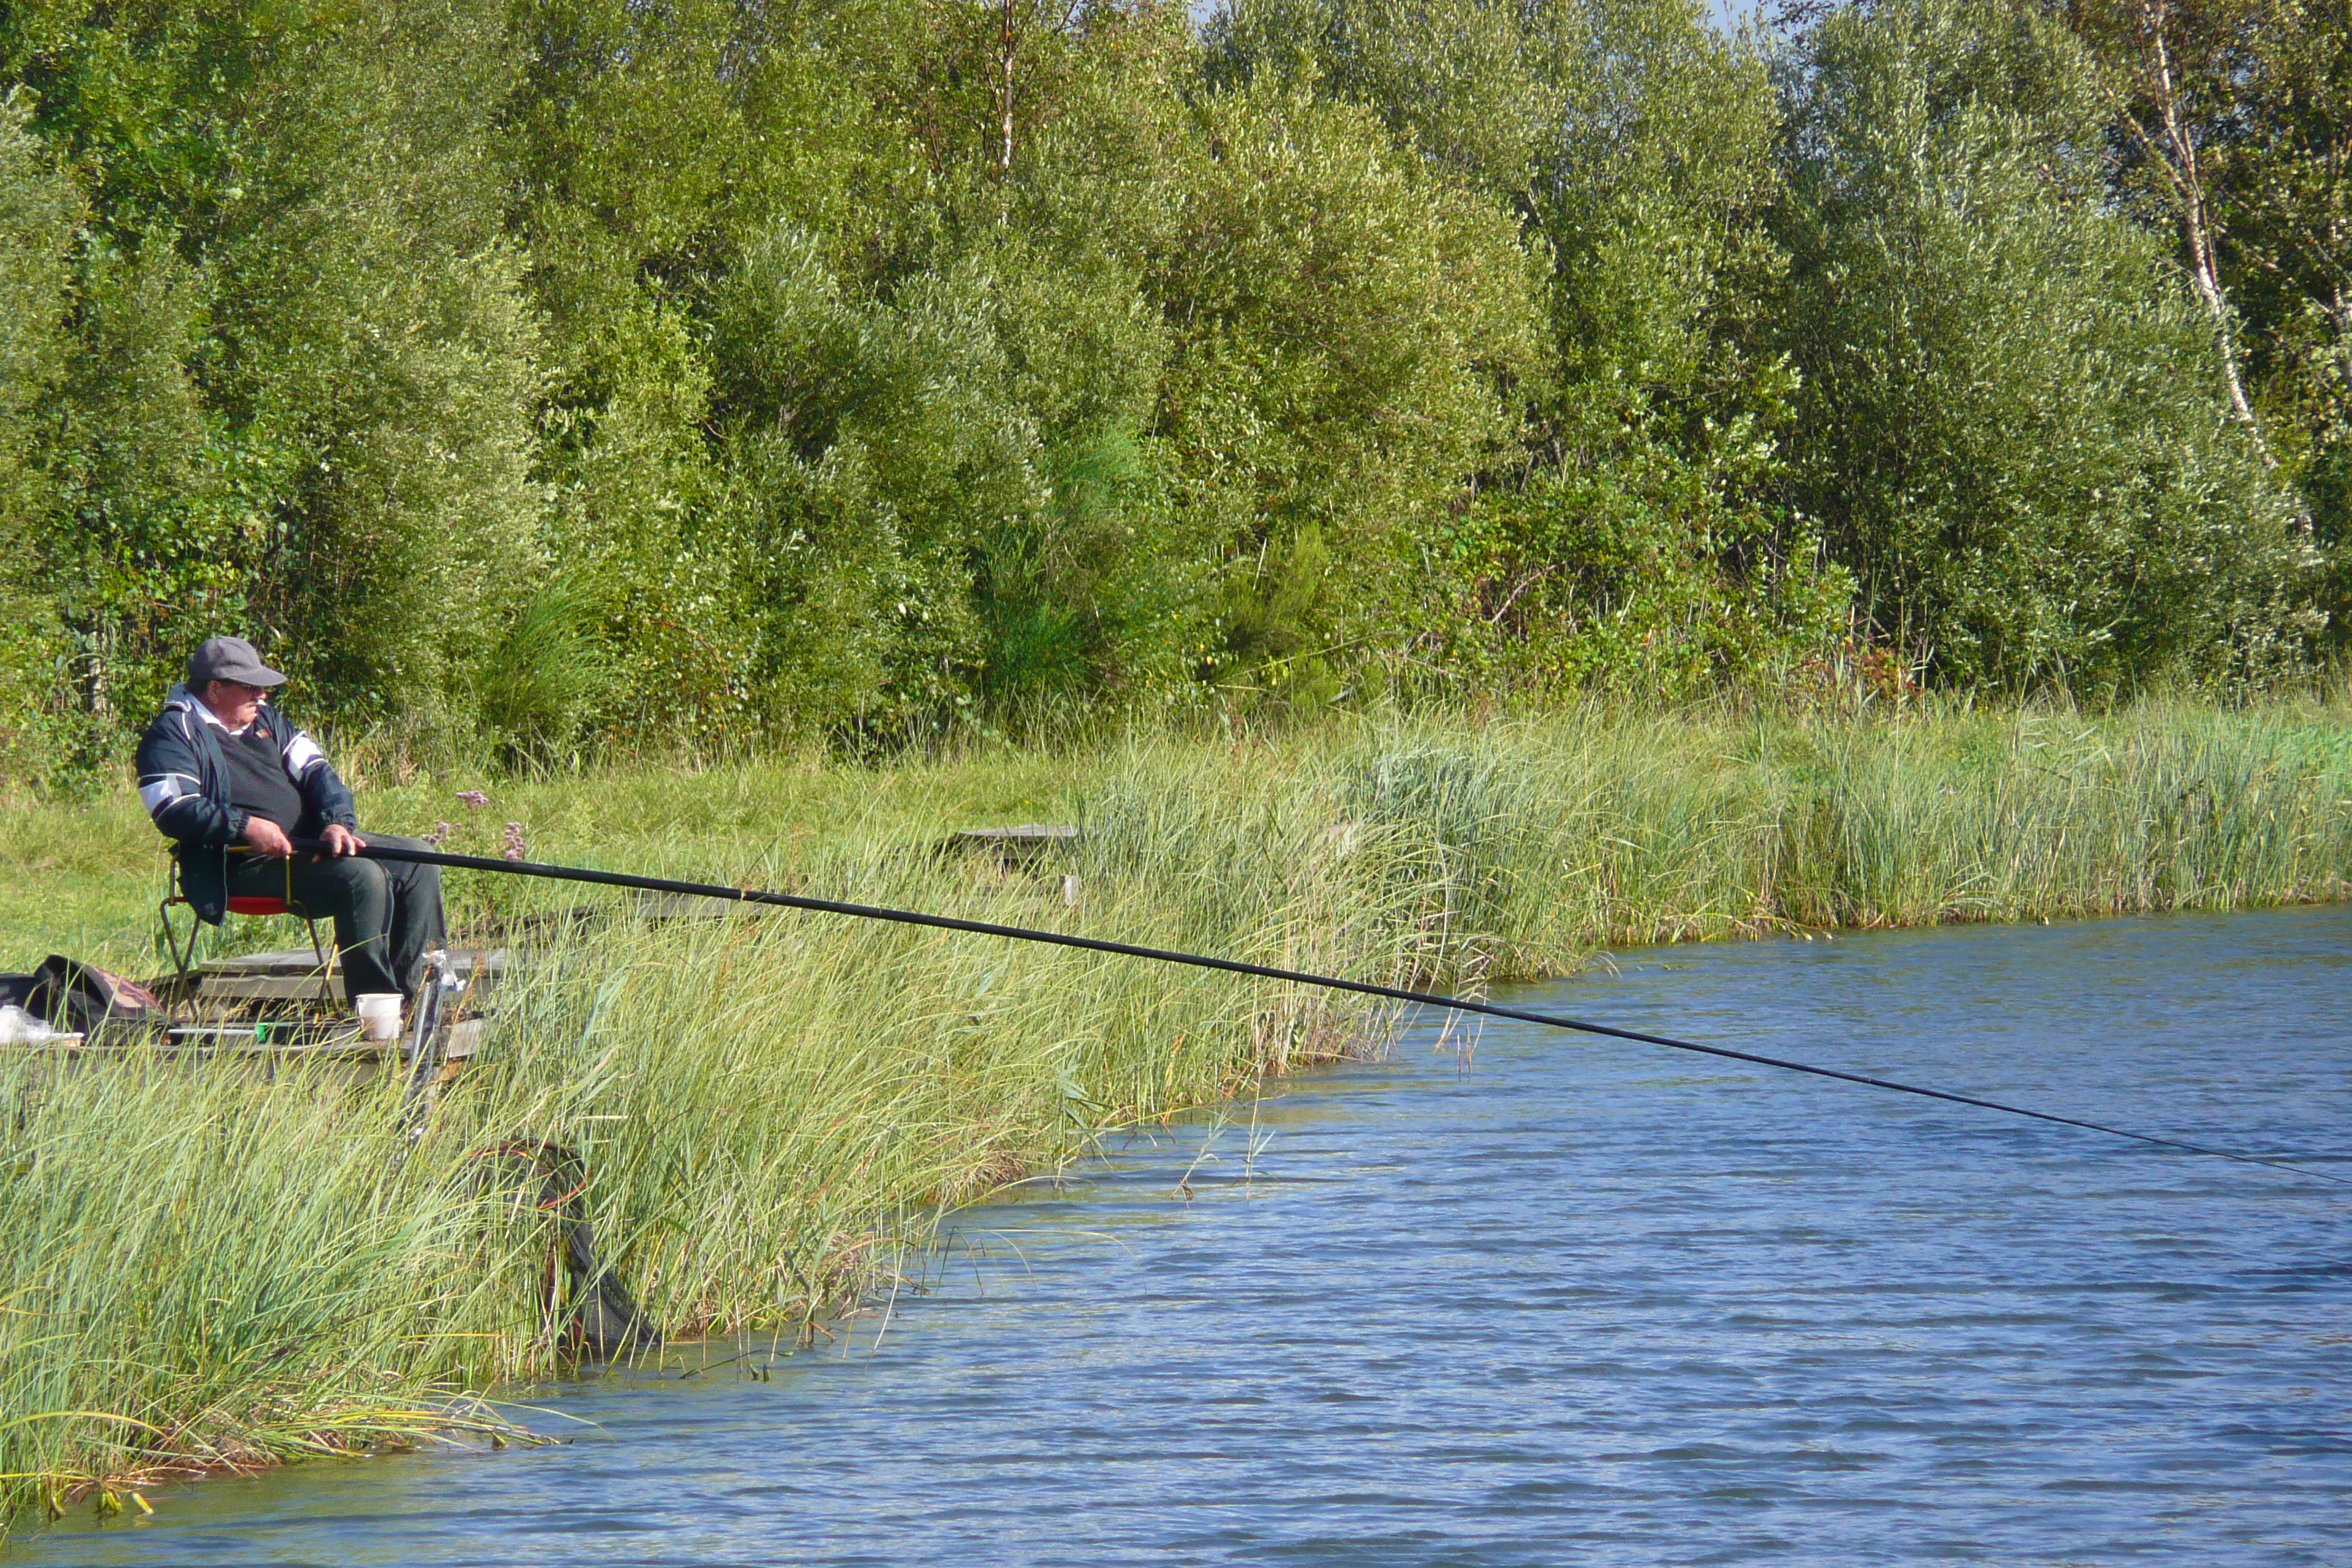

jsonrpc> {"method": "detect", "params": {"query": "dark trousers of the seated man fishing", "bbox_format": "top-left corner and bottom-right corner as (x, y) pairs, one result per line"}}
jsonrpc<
(228, 832), (449, 997)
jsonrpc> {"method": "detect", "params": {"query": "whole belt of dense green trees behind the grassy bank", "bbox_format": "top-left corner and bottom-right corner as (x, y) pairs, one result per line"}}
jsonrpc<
(0, 0), (2352, 778)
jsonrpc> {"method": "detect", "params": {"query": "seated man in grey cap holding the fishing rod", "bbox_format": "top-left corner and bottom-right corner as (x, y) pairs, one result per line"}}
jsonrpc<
(139, 637), (447, 997)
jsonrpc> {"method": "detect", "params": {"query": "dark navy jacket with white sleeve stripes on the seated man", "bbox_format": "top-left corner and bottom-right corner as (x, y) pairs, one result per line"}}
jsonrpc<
(139, 687), (360, 926)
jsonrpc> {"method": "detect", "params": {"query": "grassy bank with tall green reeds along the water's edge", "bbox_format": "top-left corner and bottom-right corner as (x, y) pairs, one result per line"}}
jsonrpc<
(0, 708), (2352, 1532)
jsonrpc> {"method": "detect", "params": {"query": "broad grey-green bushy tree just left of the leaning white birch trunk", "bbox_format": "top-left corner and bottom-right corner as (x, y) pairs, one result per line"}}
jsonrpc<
(1783, 0), (2312, 691)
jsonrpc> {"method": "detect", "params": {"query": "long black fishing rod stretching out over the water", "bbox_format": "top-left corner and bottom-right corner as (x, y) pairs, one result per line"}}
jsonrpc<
(294, 840), (2352, 1185)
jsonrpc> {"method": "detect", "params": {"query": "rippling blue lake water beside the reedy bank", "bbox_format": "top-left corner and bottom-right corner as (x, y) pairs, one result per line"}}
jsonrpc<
(21, 908), (2352, 1568)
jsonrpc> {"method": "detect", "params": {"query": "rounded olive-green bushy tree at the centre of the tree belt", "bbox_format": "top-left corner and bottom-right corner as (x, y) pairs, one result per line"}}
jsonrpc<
(1153, 83), (1540, 679)
